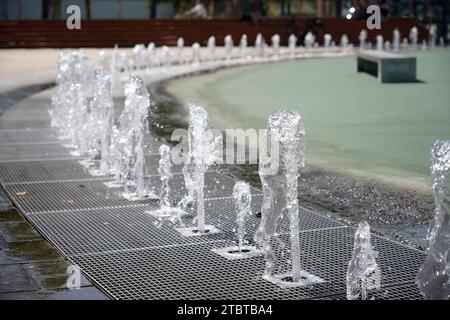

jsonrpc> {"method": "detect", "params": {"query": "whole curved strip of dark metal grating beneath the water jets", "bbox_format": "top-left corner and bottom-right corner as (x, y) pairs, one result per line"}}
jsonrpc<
(0, 87), (425, 299)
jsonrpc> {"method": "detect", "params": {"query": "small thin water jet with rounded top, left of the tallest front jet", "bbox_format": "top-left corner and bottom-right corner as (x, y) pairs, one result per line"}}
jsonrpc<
(233, 181), (252, 252)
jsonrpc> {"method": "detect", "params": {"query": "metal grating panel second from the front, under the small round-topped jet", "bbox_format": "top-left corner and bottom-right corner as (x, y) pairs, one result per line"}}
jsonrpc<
(24, 196), (341, 255)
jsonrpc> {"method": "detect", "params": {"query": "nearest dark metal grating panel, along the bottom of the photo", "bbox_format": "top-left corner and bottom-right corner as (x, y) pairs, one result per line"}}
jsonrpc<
(66, 228), (422, 299)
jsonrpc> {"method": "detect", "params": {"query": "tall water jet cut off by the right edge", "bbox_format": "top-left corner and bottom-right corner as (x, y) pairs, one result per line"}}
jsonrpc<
(416, 140), (450, 300)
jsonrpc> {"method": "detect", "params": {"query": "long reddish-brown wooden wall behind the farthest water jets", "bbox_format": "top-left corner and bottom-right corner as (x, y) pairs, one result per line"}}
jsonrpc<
(0, 18), (426, 48)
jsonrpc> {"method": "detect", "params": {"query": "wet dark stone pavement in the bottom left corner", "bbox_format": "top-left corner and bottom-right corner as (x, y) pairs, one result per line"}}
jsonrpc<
(0, 193), (108, 300)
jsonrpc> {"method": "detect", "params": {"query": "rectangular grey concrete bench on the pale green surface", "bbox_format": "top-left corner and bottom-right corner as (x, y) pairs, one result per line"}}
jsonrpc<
(356, 50), (417, 82)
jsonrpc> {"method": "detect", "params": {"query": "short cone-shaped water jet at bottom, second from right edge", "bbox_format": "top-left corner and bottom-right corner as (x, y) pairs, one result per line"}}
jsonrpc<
(347, 221), (381, 300)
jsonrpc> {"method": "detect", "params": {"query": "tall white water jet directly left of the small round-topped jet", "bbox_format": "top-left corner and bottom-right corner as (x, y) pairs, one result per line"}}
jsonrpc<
(180, 104), (222, 233)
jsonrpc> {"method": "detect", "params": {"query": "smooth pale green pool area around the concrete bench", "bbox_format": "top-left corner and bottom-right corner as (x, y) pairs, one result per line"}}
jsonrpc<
(167, 50), (450, 190)
